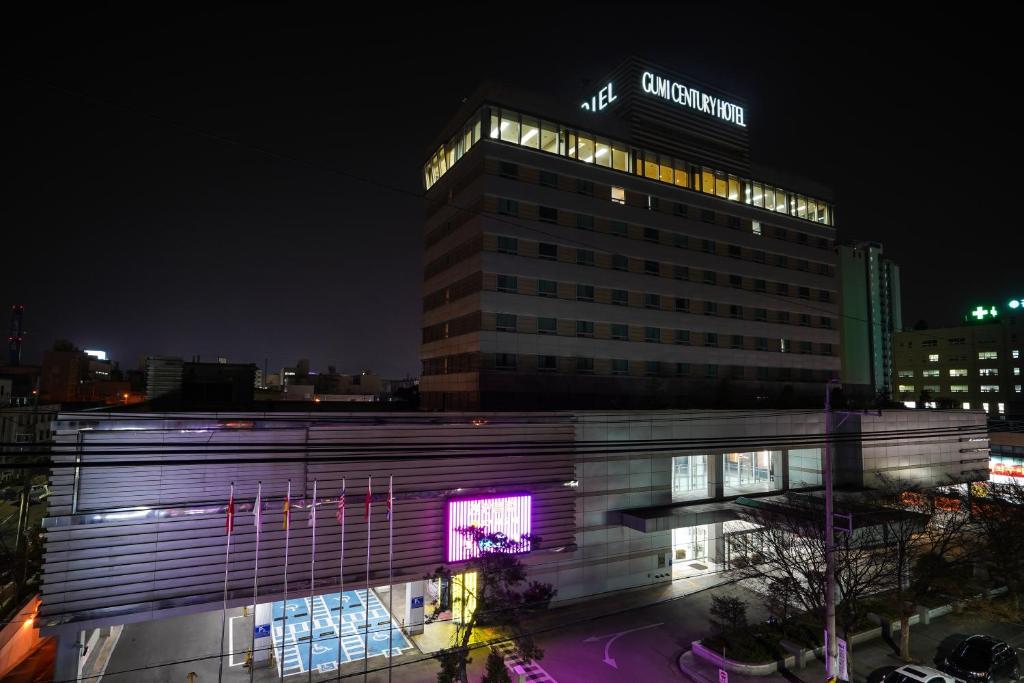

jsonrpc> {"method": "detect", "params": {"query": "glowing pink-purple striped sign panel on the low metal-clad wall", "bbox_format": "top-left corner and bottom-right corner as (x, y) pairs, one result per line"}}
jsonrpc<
(447, 494), (532, 562)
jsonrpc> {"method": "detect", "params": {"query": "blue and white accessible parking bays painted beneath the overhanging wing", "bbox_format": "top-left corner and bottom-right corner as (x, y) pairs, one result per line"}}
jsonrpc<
(271, 590), (413, 676)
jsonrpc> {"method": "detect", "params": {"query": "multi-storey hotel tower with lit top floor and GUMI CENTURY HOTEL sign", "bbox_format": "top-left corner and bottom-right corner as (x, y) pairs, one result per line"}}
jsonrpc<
(420, 59), (840, 410)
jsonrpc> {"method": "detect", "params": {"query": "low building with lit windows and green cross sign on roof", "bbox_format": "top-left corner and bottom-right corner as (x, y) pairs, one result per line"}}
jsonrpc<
(893, 305), (1024, 417)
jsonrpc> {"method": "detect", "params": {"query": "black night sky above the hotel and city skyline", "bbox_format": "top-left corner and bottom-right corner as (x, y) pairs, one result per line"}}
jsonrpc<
(0, 3), (1024, 377)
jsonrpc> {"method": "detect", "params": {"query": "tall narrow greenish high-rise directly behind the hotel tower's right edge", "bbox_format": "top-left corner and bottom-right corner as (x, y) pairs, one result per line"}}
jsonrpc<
(836, 242), (903, 396)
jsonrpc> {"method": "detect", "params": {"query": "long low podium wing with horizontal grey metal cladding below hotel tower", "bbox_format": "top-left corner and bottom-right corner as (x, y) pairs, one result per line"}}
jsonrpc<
(38, 410), (988, 678)
